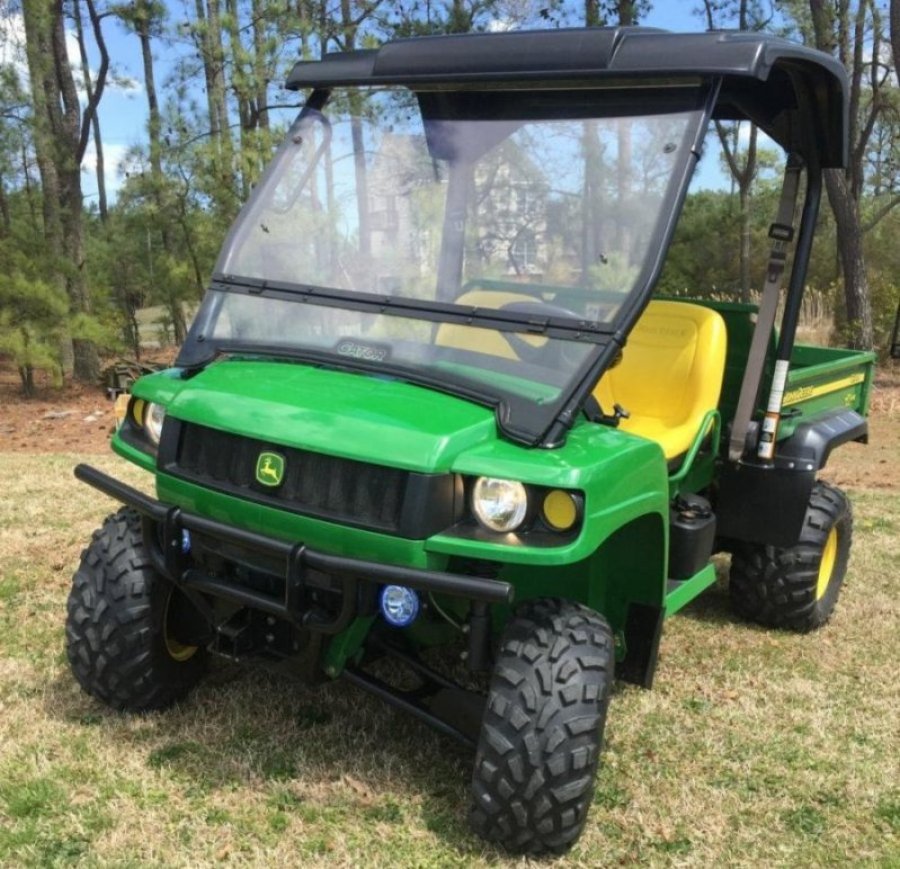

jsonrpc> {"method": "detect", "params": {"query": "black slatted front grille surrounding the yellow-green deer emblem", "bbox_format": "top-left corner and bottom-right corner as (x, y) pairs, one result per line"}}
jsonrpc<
(160, 420), (461, 537)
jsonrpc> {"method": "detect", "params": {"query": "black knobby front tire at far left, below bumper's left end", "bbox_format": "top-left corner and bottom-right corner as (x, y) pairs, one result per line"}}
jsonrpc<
(66, 508), (205, 712)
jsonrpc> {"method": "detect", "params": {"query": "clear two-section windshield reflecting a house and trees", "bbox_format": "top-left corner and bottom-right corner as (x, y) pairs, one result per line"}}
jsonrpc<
(195, 88), (702, 440)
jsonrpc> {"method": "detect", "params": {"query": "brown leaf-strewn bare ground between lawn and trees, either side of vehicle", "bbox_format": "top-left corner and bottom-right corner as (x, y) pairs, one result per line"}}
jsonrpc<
(0, 356), (900, 490)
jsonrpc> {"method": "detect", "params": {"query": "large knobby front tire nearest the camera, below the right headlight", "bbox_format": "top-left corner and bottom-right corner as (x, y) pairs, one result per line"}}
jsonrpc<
(470, 599), (614, 854)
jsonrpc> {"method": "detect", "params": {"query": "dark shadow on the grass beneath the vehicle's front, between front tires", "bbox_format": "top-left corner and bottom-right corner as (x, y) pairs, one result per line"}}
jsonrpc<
(44, 660), (501, 858)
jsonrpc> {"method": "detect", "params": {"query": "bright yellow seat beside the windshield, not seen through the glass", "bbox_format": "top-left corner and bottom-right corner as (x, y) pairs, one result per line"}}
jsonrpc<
(594, 301), (727, 461)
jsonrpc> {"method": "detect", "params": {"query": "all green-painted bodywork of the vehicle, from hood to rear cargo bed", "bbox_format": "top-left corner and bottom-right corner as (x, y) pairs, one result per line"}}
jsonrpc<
(113, 302), (874, 675)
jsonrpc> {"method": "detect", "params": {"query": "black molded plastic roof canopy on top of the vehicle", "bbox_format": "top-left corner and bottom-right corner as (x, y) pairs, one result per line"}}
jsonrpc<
(287, 27), (847, 167)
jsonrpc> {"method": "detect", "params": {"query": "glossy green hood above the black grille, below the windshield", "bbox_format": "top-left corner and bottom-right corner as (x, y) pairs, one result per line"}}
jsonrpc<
(162, 359), (497, 472)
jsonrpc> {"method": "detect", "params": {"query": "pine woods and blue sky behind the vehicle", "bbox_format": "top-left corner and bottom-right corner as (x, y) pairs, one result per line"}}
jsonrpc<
(0, 0), (900, 394)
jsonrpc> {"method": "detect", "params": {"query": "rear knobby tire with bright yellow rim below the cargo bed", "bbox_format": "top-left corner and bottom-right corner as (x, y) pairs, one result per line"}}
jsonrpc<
(729, 482), (853, 633)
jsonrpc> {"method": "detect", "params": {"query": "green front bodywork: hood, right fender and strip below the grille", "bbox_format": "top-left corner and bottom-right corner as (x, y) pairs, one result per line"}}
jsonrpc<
(134, 361), (668, 576)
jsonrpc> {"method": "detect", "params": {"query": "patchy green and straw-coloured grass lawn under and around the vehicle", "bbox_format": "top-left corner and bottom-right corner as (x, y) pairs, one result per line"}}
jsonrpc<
(0, 448), (900, 867)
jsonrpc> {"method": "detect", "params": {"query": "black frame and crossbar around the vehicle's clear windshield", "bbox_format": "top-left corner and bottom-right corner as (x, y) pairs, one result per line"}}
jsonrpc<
(176, 78), (721, 447)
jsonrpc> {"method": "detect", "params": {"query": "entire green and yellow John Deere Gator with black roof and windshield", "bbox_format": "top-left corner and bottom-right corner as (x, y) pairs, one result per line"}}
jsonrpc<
(67, 28), (873, 852)
